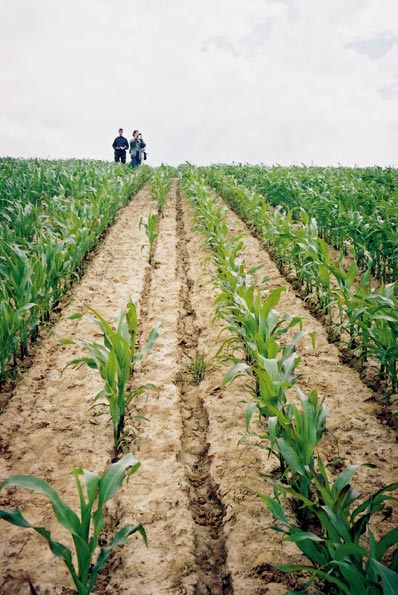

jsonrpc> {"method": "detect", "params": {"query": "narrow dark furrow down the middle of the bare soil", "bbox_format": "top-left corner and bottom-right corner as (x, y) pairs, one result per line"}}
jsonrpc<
(177, 184), (233, 595)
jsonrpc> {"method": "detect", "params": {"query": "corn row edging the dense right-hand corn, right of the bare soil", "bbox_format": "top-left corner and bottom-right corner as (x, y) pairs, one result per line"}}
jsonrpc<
(205, 168), (398, 400)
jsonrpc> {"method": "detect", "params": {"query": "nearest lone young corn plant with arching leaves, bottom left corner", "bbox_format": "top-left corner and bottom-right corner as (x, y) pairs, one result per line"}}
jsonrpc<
(0, 453), (147, 595)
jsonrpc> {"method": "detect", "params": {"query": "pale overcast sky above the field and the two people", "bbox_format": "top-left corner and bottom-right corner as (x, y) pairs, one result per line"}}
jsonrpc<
(0, 0), (398, 166)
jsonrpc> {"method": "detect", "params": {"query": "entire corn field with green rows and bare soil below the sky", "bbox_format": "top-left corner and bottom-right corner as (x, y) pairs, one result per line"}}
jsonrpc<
(0, 158), (398, 595)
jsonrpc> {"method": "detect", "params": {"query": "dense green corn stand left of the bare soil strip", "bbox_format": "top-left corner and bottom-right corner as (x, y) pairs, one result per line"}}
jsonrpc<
(0, 159), (149, 382)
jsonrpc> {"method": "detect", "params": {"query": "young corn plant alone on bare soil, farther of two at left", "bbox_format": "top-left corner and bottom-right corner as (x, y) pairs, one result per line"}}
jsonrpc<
(60, 301), (160, 457)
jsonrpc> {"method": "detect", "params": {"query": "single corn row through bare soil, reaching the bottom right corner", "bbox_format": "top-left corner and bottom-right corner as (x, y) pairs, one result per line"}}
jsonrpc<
(182, 167), (398, 595)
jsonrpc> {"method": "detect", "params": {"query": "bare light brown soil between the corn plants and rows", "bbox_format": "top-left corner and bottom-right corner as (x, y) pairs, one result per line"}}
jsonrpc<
(0, 182), (398, 595)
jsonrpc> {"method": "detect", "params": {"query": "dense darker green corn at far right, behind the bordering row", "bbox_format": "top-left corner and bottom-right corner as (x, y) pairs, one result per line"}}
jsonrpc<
(222, 165), (398, 282)
